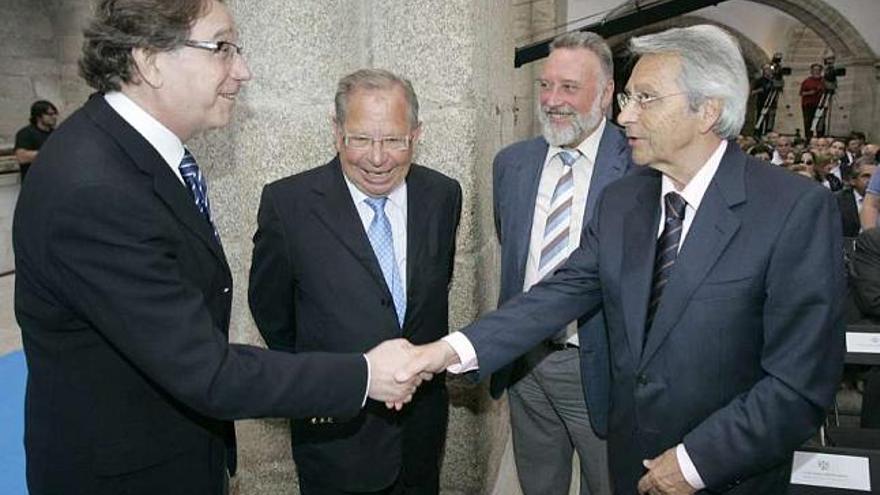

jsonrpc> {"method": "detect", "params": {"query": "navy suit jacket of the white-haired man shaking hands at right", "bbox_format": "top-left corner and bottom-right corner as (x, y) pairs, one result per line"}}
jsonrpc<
(464, 145), (844, 495)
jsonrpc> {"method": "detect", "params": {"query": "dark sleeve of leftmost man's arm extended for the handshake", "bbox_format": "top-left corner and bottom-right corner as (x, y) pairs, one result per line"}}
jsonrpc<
(46, 184), (366, 419)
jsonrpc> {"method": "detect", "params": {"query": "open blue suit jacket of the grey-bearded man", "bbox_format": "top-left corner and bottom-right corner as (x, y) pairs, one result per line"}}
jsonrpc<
(490, 122), (632, 437)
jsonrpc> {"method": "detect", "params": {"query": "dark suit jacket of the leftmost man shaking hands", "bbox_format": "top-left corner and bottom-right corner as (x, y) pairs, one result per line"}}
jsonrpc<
(13, 95), (366, 495)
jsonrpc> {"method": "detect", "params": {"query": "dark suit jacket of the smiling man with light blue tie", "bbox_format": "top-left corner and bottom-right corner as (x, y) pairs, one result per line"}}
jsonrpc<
(250, 158), (461, 491)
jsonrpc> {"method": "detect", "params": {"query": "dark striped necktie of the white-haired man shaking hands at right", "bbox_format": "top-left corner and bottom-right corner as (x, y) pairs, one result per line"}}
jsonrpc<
(645, 192), (687, 339)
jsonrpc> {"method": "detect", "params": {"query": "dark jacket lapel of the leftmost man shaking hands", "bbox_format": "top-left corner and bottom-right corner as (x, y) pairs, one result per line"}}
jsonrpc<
(86, 95), (229, 271)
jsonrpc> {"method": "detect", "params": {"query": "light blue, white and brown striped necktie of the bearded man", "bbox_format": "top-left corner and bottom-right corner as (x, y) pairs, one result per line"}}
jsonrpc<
(538, 151), (578, 280)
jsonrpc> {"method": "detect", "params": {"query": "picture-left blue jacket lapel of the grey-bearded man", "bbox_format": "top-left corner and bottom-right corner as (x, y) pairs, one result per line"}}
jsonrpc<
(504, 138), (548, 285)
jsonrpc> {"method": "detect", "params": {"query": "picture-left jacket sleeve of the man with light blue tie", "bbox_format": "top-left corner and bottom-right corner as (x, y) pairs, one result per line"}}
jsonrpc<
(248, 186), (296, 352)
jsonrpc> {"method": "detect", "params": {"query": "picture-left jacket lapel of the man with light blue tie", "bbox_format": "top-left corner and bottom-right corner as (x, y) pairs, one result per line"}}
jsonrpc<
(311, 161), (391, 299)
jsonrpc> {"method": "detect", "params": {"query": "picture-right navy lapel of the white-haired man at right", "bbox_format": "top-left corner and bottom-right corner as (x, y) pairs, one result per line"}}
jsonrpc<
(641, 145), (745, 365)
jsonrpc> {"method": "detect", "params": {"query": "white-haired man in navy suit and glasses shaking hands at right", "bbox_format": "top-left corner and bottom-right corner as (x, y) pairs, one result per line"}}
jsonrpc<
(397, 25), (845, 495)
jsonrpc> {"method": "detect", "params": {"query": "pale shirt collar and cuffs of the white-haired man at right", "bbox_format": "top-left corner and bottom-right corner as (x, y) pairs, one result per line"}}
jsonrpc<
(443, 140), (727, 490)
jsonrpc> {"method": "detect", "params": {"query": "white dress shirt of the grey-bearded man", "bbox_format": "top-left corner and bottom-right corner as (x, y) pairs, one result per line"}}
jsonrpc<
(523, 119), (605, 345)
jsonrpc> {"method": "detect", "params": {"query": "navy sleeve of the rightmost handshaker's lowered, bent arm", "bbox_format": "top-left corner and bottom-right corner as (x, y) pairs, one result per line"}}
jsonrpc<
(684, 188), (845, 488)
